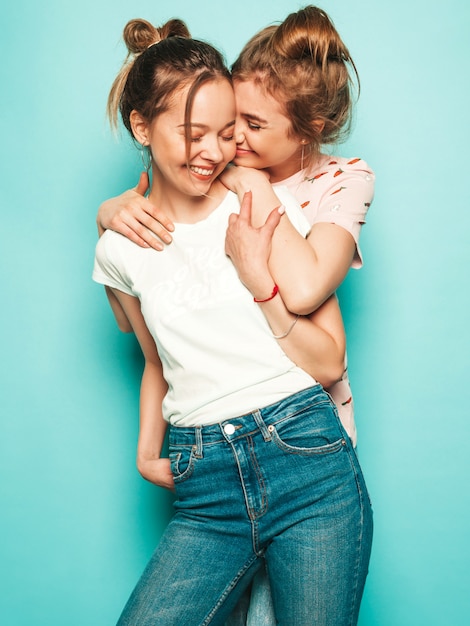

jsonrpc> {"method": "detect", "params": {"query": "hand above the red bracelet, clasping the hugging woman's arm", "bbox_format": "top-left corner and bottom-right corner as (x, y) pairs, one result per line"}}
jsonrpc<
(225, 191), (283, 298)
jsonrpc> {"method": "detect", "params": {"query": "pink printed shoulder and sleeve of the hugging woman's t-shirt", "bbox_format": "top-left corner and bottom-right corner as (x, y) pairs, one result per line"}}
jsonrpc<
(279, 154), (375, 269)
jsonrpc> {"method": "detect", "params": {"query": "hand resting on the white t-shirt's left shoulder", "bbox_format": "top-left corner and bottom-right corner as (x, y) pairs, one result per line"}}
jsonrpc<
(97, 172), (174, 250)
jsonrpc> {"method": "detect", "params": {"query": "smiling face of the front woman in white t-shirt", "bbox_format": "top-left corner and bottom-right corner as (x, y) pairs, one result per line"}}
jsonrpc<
(133, 79), (235, 214)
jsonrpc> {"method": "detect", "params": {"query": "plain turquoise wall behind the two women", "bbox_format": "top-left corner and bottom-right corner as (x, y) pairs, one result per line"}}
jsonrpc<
(0, 0), (470, 626)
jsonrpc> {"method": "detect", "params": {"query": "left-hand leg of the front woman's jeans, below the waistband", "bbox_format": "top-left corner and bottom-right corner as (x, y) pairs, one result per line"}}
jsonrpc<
(119, 438), (260, 626)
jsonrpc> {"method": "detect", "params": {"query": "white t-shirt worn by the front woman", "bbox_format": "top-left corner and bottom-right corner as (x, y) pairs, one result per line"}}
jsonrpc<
(93, 187), (316, 426)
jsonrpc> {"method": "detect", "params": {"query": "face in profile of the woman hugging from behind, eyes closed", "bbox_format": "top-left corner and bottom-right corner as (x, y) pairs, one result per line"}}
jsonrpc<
(234, 80), (302, 183)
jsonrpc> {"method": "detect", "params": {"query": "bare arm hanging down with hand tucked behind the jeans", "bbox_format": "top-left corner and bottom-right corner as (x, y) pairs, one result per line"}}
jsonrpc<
(112, 289), (174, 489)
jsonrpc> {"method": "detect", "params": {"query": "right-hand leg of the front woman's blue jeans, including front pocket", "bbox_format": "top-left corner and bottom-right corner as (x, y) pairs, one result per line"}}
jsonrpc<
(258, 390), (372, 626)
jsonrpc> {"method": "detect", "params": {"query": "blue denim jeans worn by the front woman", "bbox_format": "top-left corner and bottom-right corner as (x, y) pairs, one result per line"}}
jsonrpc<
(118, 385), (372, 626)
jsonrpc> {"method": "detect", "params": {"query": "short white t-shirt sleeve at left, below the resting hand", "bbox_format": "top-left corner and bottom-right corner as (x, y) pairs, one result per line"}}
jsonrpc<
(93, 231), (135, 296)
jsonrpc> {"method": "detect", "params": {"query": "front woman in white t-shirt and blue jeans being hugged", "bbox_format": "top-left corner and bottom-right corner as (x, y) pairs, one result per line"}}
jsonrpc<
(94, 14), (372, 626)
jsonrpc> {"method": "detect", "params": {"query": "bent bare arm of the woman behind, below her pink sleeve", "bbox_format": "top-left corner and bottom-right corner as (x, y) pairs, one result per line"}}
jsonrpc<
(222, 166), (356, 315)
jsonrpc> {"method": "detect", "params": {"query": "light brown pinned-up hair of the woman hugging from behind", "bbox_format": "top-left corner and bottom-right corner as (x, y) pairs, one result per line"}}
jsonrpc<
(232, 6), (360, 162)
